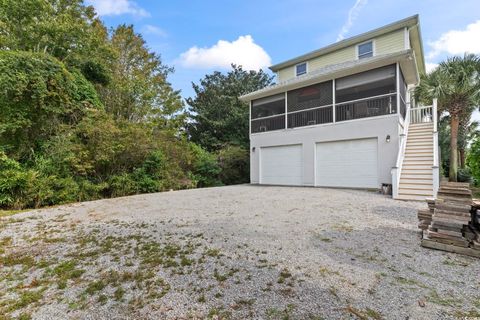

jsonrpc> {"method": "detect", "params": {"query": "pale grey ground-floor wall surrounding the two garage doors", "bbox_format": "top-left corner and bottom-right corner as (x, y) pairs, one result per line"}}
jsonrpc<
(250, 114), (399, 188)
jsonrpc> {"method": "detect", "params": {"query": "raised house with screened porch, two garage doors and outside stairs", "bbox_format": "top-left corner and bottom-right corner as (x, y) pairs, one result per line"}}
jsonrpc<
(240, 15), (438, 200)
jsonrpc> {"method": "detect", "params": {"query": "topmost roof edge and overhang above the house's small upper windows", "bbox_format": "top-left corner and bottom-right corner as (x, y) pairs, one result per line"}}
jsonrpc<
(270, 14), (425, 72)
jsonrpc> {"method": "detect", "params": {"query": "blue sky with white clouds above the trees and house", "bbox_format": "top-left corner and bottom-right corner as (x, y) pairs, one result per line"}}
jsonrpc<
(85, 0), (480, 120)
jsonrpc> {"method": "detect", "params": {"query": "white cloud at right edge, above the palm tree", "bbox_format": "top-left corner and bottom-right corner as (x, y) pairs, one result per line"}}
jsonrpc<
(428, 20), (480, 59)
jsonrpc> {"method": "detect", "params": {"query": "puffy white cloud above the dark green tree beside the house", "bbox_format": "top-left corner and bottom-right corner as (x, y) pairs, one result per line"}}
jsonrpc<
(178, 35), (271, 70)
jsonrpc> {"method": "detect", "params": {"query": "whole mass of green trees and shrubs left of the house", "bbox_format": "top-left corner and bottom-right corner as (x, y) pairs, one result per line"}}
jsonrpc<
(0, 0), (271, 210)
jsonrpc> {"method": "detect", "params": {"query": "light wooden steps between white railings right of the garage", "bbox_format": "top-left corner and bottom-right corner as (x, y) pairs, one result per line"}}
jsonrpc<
(397, 122), (434, 200)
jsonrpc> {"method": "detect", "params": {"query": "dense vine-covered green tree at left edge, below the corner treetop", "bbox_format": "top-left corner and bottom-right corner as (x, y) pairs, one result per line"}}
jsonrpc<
(0, 51), (102, 160)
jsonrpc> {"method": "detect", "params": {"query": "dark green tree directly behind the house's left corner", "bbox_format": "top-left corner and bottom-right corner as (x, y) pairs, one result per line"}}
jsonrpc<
(187, 65), (273, 151)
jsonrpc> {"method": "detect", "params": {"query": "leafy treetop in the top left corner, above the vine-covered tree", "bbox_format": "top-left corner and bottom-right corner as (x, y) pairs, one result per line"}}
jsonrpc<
(0, 0), (112, 84)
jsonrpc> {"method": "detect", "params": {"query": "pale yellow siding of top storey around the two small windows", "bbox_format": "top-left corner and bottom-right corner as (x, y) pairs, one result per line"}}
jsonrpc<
(277, 29), (406, 82)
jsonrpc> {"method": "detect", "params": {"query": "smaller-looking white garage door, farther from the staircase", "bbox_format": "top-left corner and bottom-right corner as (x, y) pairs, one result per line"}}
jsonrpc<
(260, 145), (303, 186)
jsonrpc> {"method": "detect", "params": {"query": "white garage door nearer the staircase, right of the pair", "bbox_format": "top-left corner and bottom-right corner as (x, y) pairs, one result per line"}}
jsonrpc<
(315, 138), (379, 188)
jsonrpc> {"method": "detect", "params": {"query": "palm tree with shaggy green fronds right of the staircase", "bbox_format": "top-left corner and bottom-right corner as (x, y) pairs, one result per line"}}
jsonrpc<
(415, 54), (480, 181)
